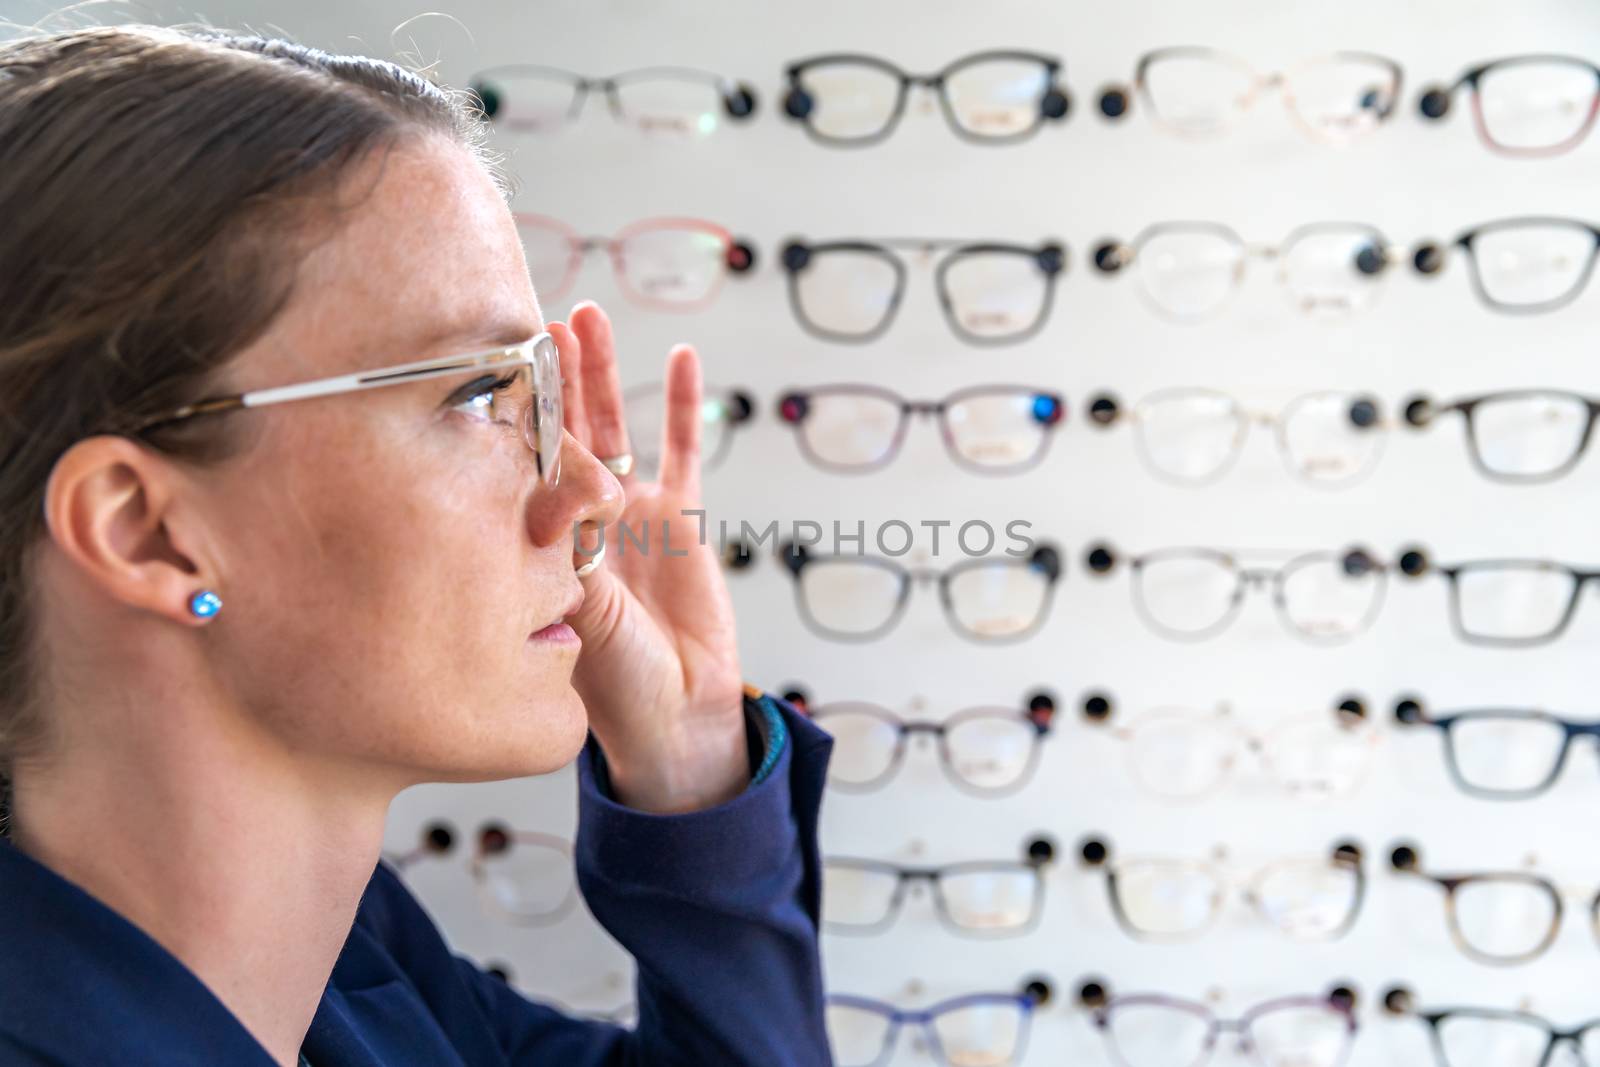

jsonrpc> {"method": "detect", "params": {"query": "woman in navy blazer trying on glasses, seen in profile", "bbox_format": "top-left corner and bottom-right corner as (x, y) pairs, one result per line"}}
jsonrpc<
(0, 18), (829, 1067)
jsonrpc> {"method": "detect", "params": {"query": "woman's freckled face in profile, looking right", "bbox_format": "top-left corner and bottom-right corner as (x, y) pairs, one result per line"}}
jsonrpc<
(192, 138), (621, 781)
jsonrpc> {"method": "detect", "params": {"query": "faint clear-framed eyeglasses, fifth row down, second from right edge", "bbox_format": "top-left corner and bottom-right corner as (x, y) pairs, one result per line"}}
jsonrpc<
(1085, 696), (1379, 800)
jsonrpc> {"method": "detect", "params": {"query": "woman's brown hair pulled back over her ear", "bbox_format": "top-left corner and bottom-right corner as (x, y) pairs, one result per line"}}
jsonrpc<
(0, 18), (504, 833)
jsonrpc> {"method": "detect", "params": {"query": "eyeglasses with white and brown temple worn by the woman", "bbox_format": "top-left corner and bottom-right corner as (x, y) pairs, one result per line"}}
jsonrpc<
(125, 333), (563, 486)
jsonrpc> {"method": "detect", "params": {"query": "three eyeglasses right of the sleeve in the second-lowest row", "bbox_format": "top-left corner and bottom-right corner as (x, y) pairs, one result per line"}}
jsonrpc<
(822, 835), (1600, 966)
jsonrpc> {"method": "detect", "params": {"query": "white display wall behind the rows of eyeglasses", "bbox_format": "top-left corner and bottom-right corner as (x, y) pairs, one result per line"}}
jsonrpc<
(62, 0), (1600, 1067)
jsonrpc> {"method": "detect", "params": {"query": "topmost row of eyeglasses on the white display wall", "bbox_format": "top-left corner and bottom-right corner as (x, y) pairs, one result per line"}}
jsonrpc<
(469, 46), (1600, 158)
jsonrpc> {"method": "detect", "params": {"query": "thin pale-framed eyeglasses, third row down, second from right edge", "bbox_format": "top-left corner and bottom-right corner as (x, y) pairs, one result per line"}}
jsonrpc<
(1088, 389), (1389, 490)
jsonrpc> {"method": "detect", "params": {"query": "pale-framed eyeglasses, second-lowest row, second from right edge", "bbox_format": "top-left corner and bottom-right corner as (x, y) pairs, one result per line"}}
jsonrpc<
(1083, 838), (1366, 941)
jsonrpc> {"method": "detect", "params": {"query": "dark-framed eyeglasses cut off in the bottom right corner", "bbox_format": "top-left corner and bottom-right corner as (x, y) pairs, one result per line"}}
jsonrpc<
(1384, 987), (1600, 1067)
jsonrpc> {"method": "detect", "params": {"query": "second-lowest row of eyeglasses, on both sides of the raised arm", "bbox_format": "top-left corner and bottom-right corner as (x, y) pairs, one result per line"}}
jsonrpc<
(386, 821), (1600, 965)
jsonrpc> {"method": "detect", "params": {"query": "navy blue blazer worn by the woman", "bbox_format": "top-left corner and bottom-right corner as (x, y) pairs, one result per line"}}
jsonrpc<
(0, 697), (832, 1067)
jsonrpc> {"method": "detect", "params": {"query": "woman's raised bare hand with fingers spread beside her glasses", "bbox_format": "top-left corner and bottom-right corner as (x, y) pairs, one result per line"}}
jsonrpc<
(550, 302), (750, 813)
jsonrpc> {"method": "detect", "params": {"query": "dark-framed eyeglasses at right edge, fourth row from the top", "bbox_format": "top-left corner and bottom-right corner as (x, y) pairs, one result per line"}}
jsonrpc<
(1400, 549), (1600, 648)
